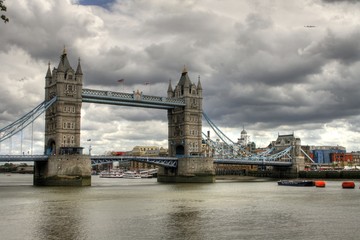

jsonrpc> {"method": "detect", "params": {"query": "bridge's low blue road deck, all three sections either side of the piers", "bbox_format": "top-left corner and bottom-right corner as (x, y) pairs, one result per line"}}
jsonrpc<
(0, 155), (292, 168)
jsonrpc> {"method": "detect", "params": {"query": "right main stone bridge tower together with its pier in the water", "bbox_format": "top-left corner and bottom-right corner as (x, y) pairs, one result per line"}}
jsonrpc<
(158, 67), (215, 182)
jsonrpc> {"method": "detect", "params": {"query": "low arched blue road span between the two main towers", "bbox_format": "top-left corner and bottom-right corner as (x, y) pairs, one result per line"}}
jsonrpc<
(91, 156), (178, 168)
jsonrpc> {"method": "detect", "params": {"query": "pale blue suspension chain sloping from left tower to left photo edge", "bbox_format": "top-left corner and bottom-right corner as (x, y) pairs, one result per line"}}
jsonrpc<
(0, 97), (56, 142)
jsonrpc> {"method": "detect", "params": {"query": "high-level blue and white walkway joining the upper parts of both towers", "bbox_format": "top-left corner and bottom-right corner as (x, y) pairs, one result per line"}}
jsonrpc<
(82, 89), (185, 109)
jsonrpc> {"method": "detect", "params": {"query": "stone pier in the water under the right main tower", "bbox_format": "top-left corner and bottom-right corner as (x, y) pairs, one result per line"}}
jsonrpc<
(157, 157), (215, 183)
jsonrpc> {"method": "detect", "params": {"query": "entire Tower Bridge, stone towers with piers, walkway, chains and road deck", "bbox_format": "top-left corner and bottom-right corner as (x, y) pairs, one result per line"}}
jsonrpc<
(0, 50), (300, 186)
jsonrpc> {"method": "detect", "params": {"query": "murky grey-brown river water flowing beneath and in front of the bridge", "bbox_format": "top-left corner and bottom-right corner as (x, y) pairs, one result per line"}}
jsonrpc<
(0, 174), (360, 240)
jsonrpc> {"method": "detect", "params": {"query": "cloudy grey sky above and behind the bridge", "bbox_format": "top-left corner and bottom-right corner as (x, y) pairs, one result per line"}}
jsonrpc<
(0, 0), (360, 154)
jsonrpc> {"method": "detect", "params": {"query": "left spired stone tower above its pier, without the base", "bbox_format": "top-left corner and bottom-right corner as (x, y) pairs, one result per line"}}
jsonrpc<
(45, 49), (83, 155)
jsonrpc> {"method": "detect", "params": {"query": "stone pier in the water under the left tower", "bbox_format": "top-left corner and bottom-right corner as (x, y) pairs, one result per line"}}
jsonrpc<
(34, 155), (91, 186)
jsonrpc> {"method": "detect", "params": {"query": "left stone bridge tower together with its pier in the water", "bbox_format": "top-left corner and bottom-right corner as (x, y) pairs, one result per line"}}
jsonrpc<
(34, 49), (91, 186)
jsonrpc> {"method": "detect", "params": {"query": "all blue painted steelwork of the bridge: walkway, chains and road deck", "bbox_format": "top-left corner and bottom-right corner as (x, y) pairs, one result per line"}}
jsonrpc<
(0, 89), (292, 168)
